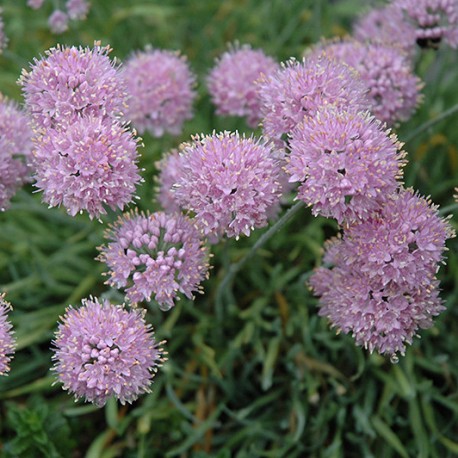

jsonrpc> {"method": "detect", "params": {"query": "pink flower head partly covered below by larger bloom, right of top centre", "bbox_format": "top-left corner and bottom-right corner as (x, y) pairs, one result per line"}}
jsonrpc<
(259, 56), (369, 146)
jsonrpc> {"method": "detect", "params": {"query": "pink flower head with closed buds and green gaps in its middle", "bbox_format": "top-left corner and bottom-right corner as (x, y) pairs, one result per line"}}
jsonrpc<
(98, 212), (208, 311)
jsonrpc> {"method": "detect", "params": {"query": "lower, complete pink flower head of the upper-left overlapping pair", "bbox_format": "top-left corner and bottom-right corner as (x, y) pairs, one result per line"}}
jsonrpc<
(33, 116), (141, 218)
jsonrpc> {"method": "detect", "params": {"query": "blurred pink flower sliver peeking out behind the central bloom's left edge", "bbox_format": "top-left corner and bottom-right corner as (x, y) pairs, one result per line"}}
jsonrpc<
(156, 150), (183, 213)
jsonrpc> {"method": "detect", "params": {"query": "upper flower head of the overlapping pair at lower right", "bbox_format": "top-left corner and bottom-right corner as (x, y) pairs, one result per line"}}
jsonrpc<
(340, 189), (454, 289)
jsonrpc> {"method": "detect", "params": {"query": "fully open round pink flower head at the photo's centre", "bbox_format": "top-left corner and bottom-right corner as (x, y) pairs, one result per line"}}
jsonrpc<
(174, 132), (282, 238)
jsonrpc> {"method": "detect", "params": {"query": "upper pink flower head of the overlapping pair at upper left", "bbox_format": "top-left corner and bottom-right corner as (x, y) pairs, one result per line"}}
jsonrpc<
(19, 43), (125, 129)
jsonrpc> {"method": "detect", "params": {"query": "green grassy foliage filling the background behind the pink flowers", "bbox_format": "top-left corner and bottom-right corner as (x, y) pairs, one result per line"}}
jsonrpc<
(0, 0), (458, 458)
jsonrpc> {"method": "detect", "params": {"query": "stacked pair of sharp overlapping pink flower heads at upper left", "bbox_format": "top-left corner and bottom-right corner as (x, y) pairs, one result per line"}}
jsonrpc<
(20, 44), (141, 218)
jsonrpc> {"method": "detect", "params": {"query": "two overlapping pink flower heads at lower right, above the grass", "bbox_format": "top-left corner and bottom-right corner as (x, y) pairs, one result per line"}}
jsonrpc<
(310, 190), (454, 362)
